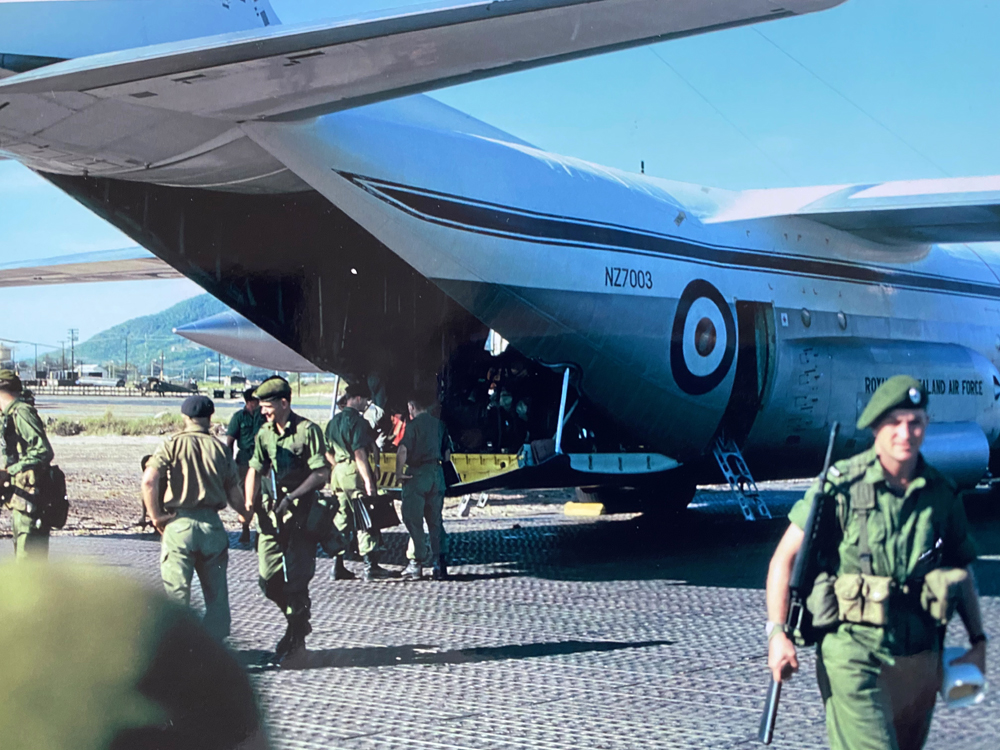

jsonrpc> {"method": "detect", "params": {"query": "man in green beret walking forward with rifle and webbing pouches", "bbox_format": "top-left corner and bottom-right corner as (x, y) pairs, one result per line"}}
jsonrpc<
(767, 375), (987, 750)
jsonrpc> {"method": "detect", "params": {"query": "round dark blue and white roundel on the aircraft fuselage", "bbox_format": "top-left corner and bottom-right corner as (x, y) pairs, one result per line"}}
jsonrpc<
(670, 279), (736, 396)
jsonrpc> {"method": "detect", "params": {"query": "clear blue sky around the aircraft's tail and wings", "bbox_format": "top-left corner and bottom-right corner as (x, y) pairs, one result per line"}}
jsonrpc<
(0, 0), (1000, 356)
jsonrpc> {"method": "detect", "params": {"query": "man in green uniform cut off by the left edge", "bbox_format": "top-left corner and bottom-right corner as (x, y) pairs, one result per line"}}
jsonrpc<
(0, 370), (54, 560)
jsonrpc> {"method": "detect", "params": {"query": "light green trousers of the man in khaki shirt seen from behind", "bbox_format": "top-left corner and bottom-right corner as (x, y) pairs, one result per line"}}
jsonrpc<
(160, 508), (230, 641)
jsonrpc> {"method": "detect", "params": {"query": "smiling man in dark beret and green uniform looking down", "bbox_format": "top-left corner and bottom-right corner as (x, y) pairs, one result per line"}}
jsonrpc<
(245, 376), (330, 664)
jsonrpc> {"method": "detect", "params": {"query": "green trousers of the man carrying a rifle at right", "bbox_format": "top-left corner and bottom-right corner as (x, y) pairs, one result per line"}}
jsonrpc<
(816, 630), (942, 750)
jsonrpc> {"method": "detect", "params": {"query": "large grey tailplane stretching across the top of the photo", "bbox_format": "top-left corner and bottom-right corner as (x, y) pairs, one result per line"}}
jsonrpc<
(0, 0), (843, 123)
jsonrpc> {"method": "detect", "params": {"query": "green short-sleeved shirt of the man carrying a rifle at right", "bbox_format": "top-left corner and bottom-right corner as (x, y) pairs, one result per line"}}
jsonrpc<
(788, 448), (976, 655)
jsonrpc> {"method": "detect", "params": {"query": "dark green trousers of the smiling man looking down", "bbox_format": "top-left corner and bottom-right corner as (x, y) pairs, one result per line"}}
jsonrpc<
(257, 512), (316, 621)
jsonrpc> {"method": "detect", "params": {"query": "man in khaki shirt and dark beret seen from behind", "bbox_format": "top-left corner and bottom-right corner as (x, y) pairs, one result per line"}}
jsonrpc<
(142, 396), (243, 641)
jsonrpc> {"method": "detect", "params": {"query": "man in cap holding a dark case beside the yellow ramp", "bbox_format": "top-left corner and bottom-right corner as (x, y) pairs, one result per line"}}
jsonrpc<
(326, 385), (392, 581)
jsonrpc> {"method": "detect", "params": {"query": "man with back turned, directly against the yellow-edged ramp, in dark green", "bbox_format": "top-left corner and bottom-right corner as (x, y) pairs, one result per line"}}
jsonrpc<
(396, 399), (452, 581)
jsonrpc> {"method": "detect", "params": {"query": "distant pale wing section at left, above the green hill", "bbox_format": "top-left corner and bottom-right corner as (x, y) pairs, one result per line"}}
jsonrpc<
(0, 247), (183, 287)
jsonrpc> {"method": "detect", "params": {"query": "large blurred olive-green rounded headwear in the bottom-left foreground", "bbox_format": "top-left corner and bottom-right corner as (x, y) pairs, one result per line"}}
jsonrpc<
(0, 561), (269, 750)
